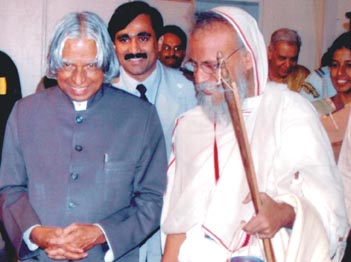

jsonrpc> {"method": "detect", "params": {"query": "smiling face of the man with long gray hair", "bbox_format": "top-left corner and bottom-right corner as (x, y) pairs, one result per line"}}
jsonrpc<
(57, 38), (104, 101)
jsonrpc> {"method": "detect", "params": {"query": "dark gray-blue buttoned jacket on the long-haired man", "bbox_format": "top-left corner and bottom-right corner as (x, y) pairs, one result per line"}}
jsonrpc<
(0, 85), (167, 262)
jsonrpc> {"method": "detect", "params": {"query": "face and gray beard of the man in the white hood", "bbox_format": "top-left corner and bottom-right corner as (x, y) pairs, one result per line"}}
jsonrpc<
(187, 23), (248, 124)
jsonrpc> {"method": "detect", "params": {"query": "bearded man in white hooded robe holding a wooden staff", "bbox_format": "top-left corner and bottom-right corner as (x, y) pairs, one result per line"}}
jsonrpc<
(161, 7), (348, 262)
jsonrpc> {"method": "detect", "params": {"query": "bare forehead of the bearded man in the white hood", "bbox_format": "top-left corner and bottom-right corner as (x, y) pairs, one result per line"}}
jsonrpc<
(188, 23), (237, 61)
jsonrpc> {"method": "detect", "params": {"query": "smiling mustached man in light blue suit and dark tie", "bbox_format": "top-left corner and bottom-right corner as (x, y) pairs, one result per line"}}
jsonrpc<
(108, 1), (196, 261)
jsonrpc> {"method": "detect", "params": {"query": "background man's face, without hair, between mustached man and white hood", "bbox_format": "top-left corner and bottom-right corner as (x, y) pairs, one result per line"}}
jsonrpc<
(159, 33), (185, 68)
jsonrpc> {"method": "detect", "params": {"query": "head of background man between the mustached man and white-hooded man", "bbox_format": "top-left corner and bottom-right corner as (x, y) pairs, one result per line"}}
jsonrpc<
(158, 25), (187, 69)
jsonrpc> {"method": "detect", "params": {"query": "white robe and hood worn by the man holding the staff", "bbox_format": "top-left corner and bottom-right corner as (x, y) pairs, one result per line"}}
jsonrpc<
(162, 7), (347, 261)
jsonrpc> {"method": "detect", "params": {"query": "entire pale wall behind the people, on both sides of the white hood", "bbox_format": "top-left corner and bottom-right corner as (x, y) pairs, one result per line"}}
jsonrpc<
(0, 0), (351, 96)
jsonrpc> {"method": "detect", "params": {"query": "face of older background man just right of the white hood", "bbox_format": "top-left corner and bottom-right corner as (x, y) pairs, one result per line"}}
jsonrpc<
(268, 41), (299, 79)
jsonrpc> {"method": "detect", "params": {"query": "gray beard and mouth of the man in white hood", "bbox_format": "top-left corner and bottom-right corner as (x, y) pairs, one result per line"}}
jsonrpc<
(196, 82), (231, 125)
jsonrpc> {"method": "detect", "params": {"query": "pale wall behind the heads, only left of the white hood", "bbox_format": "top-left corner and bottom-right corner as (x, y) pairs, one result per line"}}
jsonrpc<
(0, 0), (193, 96)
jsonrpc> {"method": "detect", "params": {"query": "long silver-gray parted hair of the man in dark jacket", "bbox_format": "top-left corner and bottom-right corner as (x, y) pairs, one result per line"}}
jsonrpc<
(47, 12), (119, 83)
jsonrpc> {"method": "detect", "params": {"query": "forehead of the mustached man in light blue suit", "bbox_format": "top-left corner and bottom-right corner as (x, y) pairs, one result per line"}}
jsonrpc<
(116, 14), (155, 36)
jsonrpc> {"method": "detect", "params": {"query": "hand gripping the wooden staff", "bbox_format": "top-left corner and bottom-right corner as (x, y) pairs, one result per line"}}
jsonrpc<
(243, 193), (295, 238)
